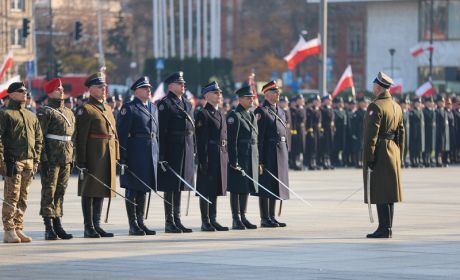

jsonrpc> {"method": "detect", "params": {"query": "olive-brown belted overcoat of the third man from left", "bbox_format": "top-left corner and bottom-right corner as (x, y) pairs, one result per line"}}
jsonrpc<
(75, 97), (120, 197)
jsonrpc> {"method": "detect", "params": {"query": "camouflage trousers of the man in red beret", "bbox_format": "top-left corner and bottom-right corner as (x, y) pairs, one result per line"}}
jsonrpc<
(40, 163), (71, 218)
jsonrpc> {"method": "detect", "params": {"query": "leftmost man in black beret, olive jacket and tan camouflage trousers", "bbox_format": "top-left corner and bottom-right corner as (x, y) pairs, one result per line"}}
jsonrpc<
(0, 82), (43, 243)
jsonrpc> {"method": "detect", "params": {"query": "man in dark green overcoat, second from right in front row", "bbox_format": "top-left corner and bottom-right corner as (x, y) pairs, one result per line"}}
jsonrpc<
(227, 86), (259, 230)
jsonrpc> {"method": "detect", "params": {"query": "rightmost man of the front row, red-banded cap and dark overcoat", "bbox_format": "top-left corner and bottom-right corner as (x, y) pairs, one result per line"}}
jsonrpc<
(255, 81), (289, 227)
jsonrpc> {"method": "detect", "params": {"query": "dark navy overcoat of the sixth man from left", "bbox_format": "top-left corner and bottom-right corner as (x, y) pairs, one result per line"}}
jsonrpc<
(196, 103), (228, 196)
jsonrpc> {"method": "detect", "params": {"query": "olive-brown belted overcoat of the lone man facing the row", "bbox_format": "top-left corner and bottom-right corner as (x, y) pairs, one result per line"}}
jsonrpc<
(363, 91), (404, 203)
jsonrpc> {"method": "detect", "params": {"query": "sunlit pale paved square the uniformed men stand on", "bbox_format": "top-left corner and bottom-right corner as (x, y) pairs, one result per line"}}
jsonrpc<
(0, 167), (460, 280)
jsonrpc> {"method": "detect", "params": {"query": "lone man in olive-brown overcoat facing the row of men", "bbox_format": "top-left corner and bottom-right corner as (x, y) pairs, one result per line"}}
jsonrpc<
(363, 72), (404, 238)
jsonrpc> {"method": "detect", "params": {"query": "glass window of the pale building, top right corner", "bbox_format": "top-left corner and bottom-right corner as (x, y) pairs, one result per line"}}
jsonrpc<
(419, 0), (460, 40)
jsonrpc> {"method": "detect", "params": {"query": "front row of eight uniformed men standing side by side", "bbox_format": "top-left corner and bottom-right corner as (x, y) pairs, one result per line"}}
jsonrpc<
(0, 72), (289, 243)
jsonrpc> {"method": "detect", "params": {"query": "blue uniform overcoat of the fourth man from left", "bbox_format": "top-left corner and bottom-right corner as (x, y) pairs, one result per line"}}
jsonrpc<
(117, 98), (159, 192)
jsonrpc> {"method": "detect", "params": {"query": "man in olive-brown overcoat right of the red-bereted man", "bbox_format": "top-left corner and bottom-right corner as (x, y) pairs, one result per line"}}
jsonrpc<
(75, 73), (120, 238)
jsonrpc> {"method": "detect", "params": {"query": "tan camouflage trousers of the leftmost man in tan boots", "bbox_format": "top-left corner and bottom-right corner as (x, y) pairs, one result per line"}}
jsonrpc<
(2, 159), (34, 231)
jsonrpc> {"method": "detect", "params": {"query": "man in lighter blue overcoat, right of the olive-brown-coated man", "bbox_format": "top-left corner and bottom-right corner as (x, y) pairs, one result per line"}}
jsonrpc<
(117, 77), (158, 235)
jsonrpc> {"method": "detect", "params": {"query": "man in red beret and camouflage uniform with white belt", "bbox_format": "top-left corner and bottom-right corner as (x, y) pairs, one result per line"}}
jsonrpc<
(37, 78), (75, 240)
